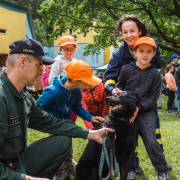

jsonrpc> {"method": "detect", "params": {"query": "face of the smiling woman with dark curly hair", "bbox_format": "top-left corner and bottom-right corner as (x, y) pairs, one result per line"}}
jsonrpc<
(121, 20), (142, 51)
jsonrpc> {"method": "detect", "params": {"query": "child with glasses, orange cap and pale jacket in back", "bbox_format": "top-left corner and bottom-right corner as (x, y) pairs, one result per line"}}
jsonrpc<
(49, 36), (77, 85)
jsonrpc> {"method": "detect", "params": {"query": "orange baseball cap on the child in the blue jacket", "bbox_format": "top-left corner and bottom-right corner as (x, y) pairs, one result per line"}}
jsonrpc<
(65, 60), (102, 86)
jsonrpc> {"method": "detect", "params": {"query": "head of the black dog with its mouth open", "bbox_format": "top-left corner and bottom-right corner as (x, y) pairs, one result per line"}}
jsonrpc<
(106, 92), (137, 121)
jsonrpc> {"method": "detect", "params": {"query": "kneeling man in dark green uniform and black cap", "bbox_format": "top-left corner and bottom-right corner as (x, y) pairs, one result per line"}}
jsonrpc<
(0, 38), (113, 180)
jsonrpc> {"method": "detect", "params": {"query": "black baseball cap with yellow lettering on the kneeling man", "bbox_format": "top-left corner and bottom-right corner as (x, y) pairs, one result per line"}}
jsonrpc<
(9, 38), (55, 65)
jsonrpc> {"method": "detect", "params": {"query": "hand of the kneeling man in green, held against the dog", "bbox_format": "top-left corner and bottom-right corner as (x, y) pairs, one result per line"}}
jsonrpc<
(87, 128), (115, 144)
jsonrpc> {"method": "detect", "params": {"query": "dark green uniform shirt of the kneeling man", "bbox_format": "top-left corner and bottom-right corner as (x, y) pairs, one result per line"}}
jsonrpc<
(0, 74), (89, 180)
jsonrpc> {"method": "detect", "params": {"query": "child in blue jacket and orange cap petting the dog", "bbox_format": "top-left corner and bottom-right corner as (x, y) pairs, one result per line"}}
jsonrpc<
(37, 60), (104, 178)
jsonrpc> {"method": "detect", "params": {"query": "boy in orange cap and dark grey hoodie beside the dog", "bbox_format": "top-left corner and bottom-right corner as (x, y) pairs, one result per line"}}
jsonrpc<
(118, 37), (169, 180)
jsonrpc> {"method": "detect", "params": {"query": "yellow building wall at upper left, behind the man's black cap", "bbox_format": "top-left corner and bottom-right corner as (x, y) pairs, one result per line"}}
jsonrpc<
(0, 7), (26, 54)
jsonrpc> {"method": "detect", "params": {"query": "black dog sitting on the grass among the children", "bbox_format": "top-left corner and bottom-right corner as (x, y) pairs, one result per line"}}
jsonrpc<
(75, 92), (137, 180)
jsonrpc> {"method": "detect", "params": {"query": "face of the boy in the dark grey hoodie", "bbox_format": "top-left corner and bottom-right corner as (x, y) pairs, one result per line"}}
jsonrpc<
(134, 44), (155, 68)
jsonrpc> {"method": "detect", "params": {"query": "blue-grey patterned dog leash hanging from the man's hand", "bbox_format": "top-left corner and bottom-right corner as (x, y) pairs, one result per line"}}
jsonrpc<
(99, 137), (118, 180)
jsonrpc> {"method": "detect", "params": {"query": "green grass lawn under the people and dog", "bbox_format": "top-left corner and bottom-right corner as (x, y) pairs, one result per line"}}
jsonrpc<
(28, 96), (180, 180)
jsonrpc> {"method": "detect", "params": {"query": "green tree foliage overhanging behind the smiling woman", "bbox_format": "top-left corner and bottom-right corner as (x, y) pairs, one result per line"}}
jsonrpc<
(39, 0), (180, 64)
